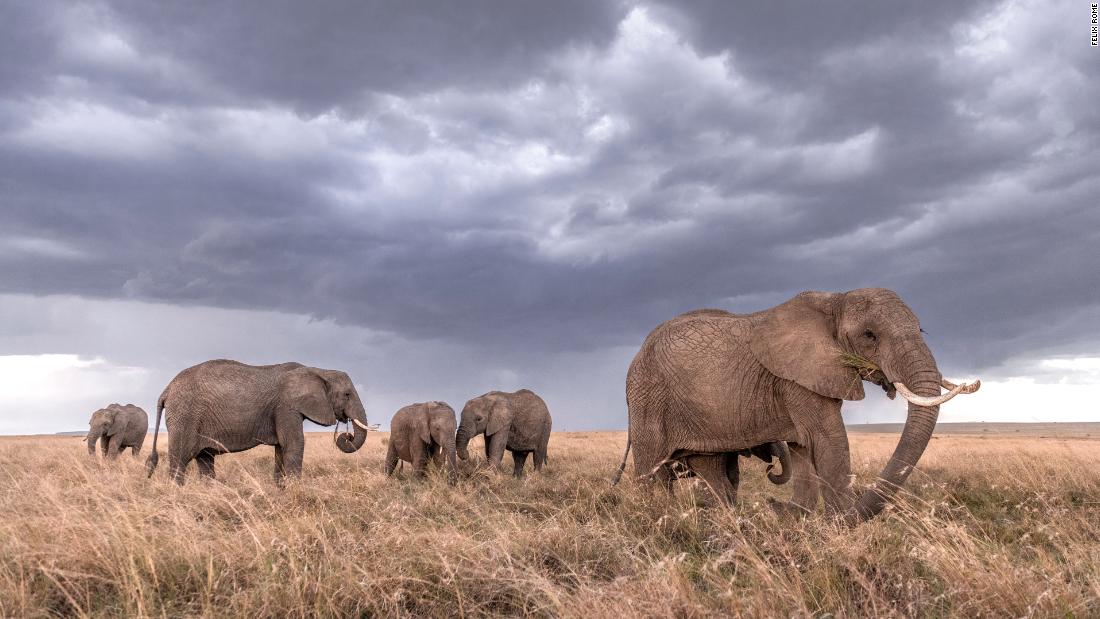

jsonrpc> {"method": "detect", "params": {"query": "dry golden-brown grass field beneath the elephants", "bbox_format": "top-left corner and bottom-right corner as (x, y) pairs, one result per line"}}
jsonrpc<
(0, 432), (1100, 617)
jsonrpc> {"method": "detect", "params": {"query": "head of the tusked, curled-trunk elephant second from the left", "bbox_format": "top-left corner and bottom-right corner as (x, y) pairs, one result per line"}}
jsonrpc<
(279, 367), (367, 453)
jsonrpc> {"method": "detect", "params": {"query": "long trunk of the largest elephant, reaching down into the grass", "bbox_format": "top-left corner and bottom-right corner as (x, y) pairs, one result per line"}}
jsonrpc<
(846, 341), (943, 523)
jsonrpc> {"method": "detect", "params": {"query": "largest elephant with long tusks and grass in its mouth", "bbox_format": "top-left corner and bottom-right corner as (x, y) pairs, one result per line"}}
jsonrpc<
(620, 288), (980, 522)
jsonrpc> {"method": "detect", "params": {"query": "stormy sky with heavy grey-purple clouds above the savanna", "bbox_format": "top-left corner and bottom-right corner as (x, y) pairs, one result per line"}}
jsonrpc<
(0, 0), (1100, 433)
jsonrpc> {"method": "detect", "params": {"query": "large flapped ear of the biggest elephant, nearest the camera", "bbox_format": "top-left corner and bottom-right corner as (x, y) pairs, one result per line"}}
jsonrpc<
(749, 292), (864, 400)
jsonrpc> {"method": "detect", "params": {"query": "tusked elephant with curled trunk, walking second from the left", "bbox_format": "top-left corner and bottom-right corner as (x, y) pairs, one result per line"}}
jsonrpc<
(145, 360), (367, 484)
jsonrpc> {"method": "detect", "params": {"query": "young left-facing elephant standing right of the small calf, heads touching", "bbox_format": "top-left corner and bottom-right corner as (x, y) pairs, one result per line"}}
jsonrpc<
(457, 389), (551, 477)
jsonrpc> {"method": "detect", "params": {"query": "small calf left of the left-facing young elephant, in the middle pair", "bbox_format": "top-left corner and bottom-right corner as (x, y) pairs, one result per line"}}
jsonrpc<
(386, 401), (458, 480)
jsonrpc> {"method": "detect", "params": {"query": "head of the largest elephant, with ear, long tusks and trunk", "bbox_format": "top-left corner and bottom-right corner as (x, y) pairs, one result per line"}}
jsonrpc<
(749, 288), (977, 521)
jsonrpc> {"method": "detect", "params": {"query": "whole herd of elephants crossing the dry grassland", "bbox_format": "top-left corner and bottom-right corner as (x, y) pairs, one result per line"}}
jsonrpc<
(87, 288), (980, 522)
